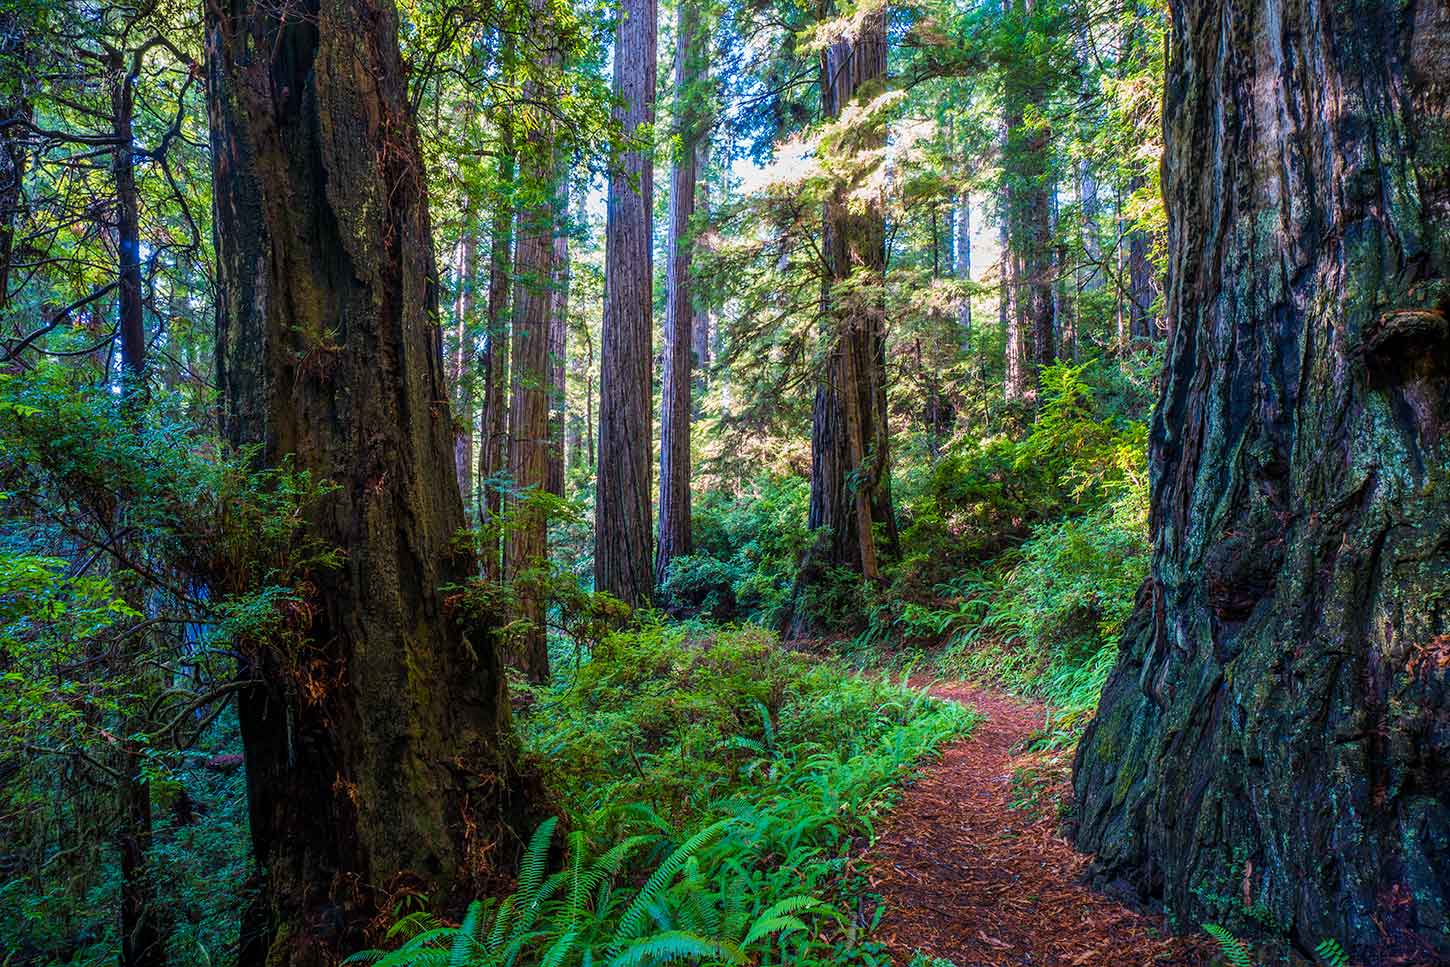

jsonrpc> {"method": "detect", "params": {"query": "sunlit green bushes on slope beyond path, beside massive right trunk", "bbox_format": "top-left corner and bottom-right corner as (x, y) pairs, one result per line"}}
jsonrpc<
(842, 362), (1150, 744)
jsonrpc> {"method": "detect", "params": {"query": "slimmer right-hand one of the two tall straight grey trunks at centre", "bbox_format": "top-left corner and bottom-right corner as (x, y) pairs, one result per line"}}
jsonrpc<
(654, 0), (706, 584)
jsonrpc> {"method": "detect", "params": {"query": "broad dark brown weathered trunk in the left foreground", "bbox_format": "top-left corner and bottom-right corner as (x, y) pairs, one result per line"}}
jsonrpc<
(206, 0), (525, 967)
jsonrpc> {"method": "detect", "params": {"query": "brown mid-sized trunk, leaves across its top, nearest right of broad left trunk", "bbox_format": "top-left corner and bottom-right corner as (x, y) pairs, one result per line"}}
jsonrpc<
(505, 22), (556, 683)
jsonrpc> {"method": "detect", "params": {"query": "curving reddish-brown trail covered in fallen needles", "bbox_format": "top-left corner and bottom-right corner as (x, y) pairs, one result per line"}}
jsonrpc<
(864, 683), (1215, 967)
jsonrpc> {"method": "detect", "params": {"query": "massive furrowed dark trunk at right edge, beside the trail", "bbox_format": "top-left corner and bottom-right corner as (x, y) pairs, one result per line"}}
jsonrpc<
(1074, 0), (1450, 964)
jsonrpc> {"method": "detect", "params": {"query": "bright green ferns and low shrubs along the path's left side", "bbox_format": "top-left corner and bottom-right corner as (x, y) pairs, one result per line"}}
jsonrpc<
(363, 625), (976, 967)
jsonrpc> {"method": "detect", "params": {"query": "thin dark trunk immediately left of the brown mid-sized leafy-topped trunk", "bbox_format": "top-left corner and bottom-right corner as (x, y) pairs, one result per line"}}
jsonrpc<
(479, 115), (515, 581)
